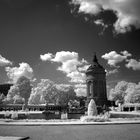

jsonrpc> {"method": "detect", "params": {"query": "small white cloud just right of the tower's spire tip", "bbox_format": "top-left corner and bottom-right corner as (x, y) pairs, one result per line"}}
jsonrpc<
(102, 51), (131, 67)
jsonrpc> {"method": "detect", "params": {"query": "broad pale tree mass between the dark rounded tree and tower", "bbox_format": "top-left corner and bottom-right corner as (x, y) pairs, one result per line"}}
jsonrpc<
(29, 79), (76, 105)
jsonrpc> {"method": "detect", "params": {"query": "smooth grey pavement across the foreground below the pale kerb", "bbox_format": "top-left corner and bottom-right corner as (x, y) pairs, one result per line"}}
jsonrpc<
(0, 124), (140, 140)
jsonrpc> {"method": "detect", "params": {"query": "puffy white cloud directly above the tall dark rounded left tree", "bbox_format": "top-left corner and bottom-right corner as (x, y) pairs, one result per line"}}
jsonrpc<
(5, 62), (33, 83)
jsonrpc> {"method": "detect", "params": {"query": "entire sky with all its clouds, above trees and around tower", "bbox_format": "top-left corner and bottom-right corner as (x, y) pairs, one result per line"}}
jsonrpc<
(0, 0), (140, 94)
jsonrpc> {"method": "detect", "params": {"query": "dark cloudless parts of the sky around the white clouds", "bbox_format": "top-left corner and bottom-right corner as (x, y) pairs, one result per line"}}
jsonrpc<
(0, 0), (140, 90)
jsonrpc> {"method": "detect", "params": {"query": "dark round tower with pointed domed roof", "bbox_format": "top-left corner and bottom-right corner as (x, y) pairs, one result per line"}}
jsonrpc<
(86, 54), (109, 107)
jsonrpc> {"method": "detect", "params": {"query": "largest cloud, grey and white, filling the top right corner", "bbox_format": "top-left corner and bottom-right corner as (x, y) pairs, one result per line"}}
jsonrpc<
(71, 0), (140, 33)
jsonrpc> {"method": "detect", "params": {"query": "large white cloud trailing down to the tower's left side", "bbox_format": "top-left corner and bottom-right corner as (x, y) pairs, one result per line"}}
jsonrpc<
(41, 51), (88, 83)
